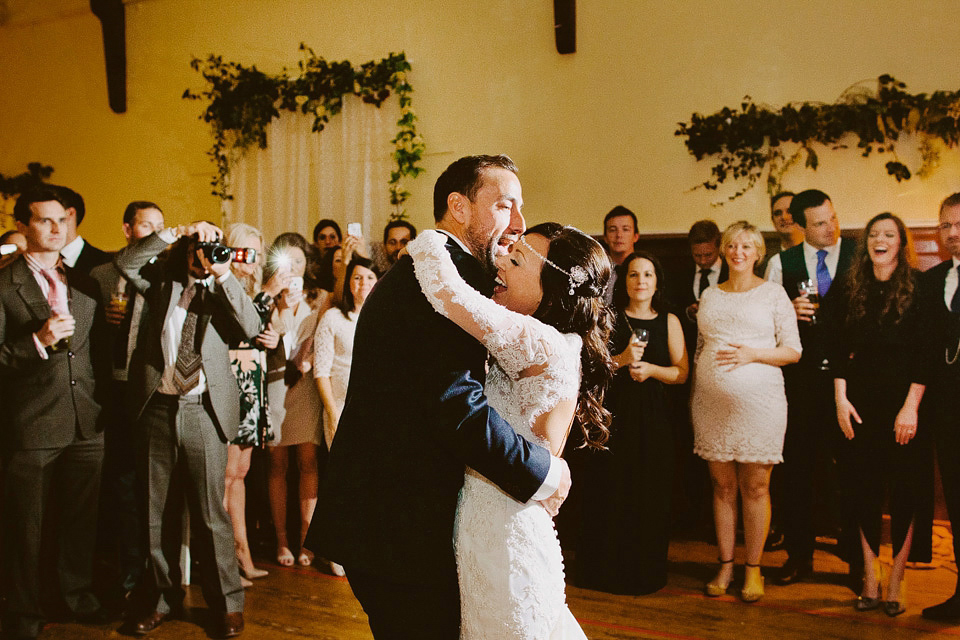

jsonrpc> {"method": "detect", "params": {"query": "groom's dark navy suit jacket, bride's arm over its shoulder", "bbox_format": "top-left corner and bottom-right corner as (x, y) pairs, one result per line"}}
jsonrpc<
(307, 236), (550, 583)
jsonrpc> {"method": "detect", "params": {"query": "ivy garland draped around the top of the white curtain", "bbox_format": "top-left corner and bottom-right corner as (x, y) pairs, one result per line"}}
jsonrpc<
(183, 43), (426, 219)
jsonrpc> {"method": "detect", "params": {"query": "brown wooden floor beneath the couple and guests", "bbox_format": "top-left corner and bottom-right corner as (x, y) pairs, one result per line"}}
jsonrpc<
(40, 542), (960, 640)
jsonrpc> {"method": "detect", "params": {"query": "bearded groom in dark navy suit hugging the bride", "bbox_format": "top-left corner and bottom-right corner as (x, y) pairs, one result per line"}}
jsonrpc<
(310, 155), (570, 640)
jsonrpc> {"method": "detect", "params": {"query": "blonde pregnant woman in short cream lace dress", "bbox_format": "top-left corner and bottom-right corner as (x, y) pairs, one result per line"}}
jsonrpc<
(691, 221), (801, 602)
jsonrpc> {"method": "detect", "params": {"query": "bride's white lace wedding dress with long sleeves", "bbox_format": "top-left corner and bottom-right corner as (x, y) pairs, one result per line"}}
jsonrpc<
(407, 231), (586, 640)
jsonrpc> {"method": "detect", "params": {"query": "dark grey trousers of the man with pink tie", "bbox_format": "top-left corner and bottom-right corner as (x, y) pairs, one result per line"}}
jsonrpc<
(3, 436), (103, 636)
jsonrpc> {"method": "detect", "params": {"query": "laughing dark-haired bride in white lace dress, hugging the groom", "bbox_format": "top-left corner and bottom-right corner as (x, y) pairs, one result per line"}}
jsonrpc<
(407, 223), (612, 640)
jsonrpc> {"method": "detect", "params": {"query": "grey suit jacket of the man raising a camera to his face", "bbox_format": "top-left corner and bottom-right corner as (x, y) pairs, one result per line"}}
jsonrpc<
(114, 234), (263, 442)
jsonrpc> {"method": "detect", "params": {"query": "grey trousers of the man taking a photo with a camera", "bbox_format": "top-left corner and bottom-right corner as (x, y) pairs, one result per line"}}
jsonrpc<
(140, 393), (243, 613)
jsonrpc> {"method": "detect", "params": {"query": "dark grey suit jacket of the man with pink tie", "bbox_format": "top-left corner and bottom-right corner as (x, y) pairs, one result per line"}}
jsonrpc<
(0, 256), (102, 451)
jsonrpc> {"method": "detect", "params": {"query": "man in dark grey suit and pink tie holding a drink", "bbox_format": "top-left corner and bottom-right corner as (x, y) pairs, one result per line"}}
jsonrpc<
(0, 186), (103, 638)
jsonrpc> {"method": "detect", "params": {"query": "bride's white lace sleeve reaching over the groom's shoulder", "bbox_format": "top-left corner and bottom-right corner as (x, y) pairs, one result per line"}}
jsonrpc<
(407, 230), (561, 378)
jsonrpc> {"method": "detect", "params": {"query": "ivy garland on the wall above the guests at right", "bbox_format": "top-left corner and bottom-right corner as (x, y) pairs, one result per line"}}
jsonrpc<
(674, 75), (960, 204)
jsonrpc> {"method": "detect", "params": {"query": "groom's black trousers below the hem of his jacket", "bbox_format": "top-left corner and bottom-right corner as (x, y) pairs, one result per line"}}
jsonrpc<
(344, 567), (460, 640)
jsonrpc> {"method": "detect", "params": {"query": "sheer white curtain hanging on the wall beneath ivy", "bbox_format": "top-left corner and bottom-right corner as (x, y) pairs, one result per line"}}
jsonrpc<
(223, 95), (400, 245)
